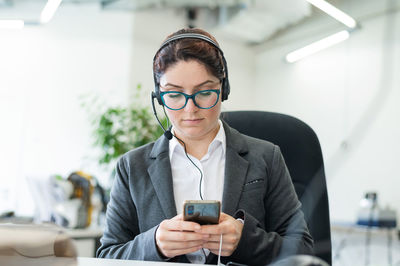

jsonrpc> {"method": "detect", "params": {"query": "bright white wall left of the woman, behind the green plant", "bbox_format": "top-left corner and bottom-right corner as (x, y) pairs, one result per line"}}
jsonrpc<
(0, 3), (133, 215)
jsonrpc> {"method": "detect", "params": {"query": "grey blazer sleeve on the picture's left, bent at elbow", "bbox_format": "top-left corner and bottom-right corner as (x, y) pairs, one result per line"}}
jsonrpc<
(96, 157), (163, 261)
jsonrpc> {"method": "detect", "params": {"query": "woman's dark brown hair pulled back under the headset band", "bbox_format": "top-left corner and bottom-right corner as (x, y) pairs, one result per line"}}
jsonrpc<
(153, 29), (225, 84)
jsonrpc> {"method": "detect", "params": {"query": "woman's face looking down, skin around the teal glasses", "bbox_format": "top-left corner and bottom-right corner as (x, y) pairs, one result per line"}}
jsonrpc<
(160, 60), (221, 140)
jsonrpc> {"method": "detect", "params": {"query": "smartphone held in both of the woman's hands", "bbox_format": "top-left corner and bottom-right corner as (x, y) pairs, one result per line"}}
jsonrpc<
(183, 200), (221, 225)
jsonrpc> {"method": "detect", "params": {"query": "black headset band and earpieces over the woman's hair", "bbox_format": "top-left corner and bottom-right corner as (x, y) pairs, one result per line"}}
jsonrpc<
(153, 33), (230, 105)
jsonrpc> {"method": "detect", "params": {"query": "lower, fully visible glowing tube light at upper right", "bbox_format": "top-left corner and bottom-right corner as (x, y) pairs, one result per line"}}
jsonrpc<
(286, 30), (350, 63)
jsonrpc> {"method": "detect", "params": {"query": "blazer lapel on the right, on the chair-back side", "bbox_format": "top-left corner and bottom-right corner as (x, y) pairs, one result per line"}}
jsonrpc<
(222, 122), (249, 215)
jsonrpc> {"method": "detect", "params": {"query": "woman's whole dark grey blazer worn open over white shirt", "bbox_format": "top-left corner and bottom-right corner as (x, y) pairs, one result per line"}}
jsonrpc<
(97, 123), (313, 265)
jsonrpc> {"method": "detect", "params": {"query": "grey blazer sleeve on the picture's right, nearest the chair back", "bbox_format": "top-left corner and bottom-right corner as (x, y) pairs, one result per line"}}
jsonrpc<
(225, 146), (313, 265)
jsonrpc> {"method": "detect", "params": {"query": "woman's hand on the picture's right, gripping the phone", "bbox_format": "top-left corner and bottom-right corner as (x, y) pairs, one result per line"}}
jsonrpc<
(201, 212), (243, 256)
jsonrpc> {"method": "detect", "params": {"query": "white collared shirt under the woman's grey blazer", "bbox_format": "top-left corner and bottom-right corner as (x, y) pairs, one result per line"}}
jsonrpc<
(169, 120), (226, 263)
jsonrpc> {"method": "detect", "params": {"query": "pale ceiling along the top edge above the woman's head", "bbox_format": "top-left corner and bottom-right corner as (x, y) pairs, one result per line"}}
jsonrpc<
(0, 0), (312, 43)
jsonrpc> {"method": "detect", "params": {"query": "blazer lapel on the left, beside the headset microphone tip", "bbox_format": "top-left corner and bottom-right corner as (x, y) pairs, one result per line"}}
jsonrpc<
(147, 136), (177, 219)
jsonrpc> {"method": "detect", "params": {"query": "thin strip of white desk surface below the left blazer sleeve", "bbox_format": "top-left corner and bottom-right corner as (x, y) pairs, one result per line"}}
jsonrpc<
(78, 257), (200, 266)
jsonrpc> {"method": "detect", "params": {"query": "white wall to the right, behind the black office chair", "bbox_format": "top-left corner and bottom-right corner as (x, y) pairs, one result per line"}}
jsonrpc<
(253, 0), (400, 222)
